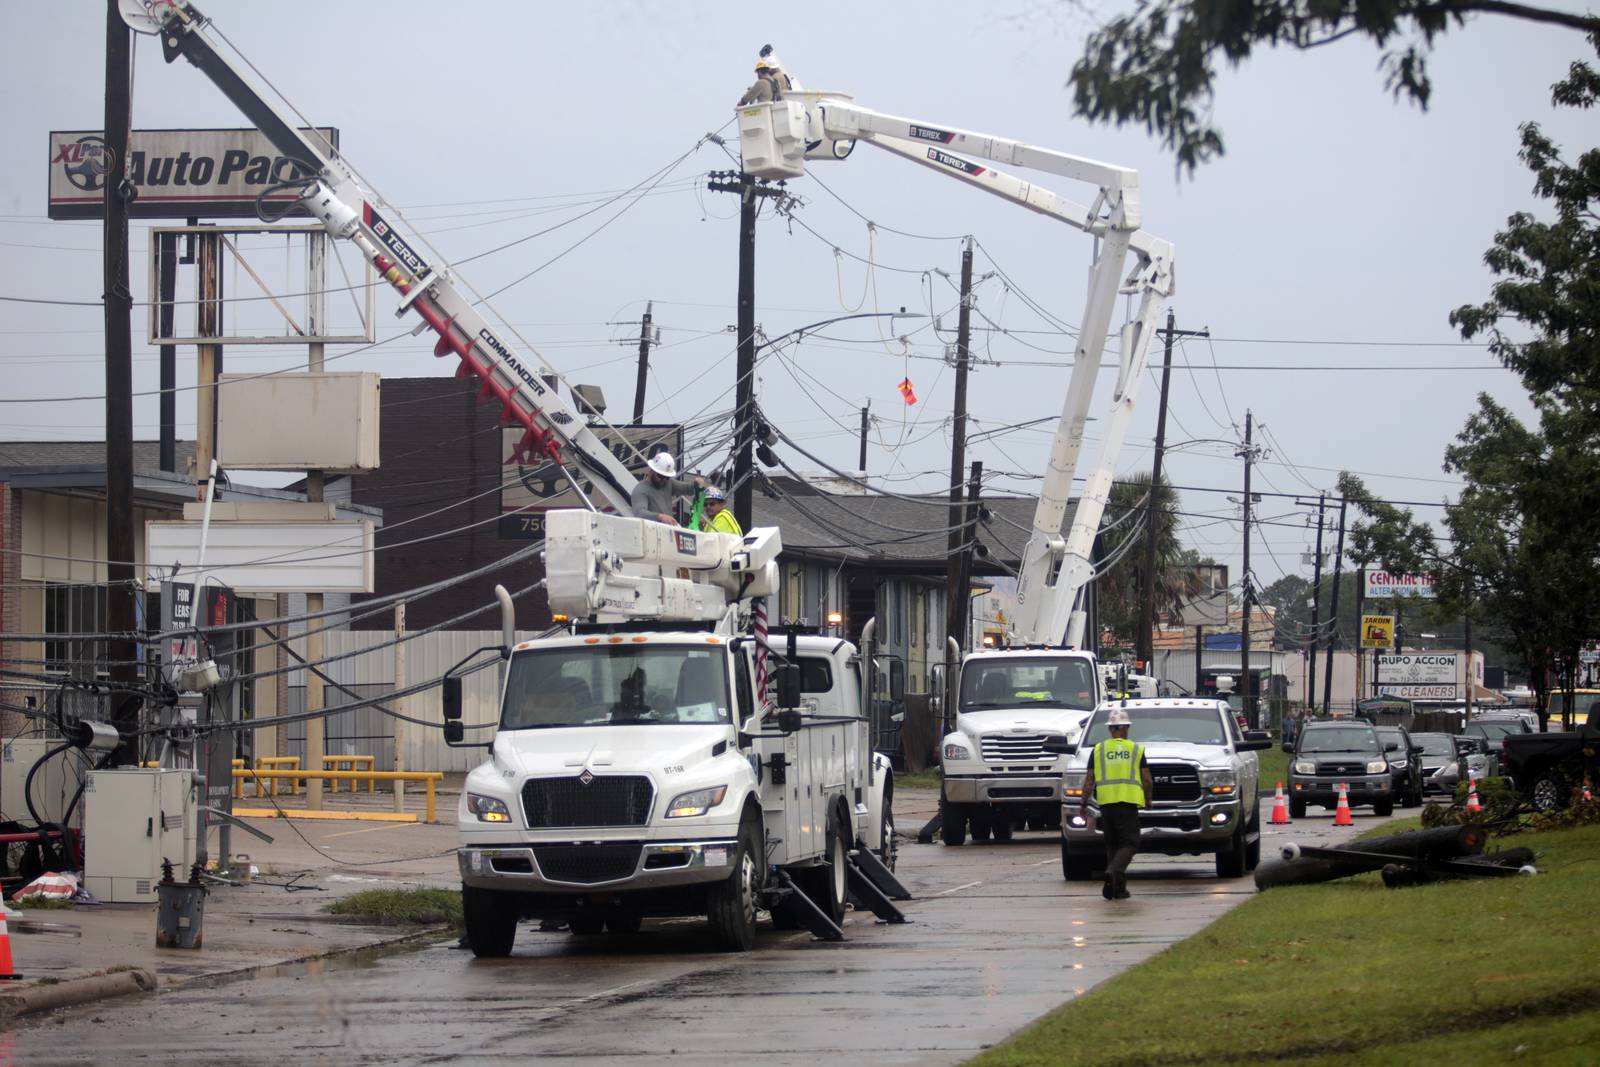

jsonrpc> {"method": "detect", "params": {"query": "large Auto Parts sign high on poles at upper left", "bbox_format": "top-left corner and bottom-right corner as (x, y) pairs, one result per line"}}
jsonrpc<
(48, 126), (339, 219)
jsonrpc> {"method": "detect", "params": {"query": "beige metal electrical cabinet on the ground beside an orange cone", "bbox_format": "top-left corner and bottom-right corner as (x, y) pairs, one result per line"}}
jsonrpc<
(83, 768), (198, 904)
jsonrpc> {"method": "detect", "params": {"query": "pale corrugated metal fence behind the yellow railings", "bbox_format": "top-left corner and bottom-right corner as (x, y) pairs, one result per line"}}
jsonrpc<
(290, 630), (534, 771)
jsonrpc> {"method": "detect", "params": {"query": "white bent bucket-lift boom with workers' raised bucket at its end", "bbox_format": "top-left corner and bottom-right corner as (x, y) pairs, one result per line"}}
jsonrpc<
(738, 91), (1174, 645)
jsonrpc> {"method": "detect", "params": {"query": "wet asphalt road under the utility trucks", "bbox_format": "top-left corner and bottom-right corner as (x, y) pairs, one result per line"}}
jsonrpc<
(10, 805), (1381, 1067)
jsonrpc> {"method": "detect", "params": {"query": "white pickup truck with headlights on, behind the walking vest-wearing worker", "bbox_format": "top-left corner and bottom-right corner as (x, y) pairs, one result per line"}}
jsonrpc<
(1046, 697), (1272, 880)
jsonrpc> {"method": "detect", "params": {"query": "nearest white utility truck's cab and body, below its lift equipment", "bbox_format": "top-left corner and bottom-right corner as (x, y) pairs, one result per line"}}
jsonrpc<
(445, 629), (894, 957)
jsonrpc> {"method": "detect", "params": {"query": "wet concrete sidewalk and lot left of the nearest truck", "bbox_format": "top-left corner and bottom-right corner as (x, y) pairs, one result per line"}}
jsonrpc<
(0, 776), (461, 992)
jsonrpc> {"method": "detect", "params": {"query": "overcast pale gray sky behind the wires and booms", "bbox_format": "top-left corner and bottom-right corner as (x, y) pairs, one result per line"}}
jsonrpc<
(0, 0), (1594, 584)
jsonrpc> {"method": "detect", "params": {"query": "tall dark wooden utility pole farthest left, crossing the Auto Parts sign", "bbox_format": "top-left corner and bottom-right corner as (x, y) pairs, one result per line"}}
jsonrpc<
(102, 0), (139, 765)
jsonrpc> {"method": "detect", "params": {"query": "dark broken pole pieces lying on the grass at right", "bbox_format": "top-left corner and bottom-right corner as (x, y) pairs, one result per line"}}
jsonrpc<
(1256, 824), (1531, 889)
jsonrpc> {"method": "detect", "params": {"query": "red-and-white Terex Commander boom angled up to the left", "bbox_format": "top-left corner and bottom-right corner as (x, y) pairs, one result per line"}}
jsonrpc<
(118, 0), (635, 512)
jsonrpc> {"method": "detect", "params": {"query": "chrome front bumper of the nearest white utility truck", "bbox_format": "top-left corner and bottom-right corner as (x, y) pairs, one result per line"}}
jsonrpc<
(456, 838), (739, 893)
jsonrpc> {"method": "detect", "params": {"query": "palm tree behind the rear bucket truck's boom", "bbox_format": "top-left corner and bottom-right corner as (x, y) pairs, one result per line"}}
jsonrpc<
(1096, 474), (1202, 645)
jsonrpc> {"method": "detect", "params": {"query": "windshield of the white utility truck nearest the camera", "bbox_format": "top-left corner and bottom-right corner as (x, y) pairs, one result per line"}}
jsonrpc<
(501, 645), (730, 729)
